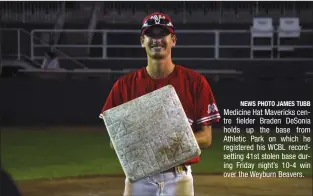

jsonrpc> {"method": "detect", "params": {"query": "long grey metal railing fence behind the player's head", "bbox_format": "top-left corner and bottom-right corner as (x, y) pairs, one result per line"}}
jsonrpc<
(31, 29), (313, 61)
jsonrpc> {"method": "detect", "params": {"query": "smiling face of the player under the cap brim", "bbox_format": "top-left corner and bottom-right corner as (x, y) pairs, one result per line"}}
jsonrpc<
(141, 26), (176, 59)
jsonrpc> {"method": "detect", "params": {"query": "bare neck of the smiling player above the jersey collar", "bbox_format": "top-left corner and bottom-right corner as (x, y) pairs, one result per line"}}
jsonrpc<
(147, 56), (175, 79)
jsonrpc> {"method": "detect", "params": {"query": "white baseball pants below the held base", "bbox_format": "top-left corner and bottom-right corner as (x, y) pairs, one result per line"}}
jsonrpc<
(123, 166), (194, 196)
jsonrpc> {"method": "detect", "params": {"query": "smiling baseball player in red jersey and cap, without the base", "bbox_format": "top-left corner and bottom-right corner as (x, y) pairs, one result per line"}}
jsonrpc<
(101, 12), (220, 196)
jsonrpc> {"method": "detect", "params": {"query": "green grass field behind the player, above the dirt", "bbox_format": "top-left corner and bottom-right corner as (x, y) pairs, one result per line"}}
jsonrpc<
(1, 128), (312, 180)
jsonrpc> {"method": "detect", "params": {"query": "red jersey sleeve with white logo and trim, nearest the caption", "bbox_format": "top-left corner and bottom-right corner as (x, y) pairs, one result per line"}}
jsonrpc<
(195, 76), (221, 127)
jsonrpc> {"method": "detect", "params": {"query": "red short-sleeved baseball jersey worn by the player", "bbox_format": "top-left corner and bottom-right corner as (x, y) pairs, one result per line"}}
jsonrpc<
(101, 65), (220, 164)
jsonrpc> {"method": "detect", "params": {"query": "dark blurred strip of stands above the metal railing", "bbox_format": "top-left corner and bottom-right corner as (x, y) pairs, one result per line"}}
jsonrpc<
(0, 1), (313, 24)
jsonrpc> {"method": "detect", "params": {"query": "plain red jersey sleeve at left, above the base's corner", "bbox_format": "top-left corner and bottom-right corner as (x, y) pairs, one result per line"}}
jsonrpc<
(99, 80), (123, 118)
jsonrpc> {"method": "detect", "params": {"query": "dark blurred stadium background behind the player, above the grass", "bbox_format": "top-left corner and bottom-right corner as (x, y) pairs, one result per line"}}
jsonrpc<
(0, 1), (313, 125)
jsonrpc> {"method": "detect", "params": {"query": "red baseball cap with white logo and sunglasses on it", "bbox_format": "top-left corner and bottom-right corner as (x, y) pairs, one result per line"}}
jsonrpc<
(141, 12), (175, 35)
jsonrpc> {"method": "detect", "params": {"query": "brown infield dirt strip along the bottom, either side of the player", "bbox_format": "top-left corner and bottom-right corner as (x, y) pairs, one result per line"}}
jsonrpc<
(18, 175), (312, 196)
